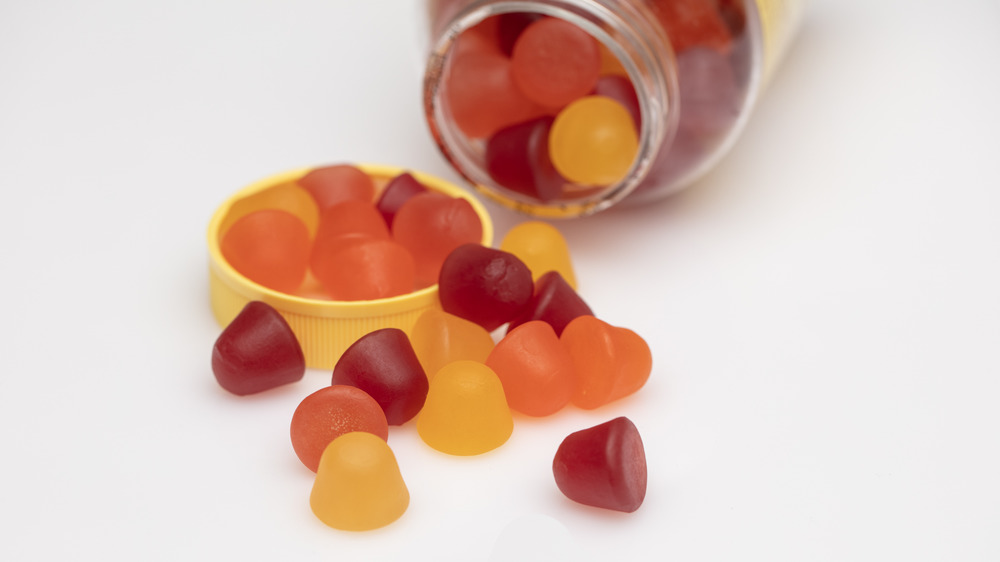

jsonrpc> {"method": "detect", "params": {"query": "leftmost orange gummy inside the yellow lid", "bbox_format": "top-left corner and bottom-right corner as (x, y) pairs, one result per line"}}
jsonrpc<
(219, 209), (312, 293)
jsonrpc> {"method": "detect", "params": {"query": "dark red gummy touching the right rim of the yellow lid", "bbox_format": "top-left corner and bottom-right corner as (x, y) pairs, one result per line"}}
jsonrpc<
(438, 244), (534, 331)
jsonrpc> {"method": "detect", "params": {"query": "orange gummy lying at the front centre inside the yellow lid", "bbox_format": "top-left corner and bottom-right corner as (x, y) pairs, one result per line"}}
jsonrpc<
(313, 238), (416, 301)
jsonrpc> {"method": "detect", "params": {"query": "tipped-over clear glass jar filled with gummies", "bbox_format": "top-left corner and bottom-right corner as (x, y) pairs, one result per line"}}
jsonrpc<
(424, 0), (801, 218)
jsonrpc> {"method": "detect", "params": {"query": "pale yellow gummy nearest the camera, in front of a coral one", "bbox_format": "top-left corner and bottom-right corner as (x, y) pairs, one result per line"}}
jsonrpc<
(309, 431), (410, 531)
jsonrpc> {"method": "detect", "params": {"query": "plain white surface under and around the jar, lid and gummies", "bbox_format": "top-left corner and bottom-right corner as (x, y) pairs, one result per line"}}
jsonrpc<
(0, 0), (1000, 561)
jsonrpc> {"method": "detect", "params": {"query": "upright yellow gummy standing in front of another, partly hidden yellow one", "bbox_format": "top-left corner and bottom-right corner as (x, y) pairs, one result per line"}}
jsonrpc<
(417, 361), (514, 455)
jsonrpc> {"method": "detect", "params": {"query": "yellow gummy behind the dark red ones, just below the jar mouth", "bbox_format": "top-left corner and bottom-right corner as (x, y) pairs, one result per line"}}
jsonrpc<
(500, 221), (576, 290)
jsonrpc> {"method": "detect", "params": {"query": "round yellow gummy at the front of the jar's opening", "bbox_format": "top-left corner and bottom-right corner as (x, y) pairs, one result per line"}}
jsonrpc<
(549, 96), (639, 185)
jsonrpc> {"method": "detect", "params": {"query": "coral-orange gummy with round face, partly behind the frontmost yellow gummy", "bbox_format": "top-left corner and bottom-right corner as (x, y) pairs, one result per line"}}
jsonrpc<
(290, 384), (389, 472)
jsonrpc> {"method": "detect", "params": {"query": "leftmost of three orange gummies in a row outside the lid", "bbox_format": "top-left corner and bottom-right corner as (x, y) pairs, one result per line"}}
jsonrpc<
(486, 320), (576, 416)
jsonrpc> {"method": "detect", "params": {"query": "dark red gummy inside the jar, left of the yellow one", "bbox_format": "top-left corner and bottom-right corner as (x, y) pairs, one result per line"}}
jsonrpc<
(485, 116), (566, 201)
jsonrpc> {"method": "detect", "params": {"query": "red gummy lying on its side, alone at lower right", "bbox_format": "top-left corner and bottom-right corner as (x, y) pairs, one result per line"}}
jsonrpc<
(552, 417), (647, 513)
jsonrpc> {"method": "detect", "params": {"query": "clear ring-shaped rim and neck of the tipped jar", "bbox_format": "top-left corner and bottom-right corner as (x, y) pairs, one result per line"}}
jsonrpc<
(424, 0), (679, 218)
